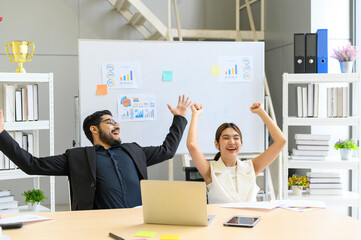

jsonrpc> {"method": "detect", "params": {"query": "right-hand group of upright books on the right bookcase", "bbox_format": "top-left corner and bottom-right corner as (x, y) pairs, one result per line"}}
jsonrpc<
(327, 87), (349, 118)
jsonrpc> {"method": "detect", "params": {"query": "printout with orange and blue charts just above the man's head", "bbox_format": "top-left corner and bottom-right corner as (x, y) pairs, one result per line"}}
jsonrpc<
(118, 94), (156, 122)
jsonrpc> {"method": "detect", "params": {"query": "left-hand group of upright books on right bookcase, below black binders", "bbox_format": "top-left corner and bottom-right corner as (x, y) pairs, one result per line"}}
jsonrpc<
(297, 83), (319, 117)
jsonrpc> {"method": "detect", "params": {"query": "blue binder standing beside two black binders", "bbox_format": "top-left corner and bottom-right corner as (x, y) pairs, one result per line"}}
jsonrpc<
(317, 29), (328, 73)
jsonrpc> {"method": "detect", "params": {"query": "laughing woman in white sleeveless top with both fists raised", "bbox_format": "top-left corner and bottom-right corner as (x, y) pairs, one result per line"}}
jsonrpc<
(187, 102), (286, 203)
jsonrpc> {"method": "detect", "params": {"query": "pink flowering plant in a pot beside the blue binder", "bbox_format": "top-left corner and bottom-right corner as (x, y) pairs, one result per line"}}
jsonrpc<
(331, 43), (359, 73)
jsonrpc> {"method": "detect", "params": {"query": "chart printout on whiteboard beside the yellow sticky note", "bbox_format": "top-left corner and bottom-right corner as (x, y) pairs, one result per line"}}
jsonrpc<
(219, 56), (254, 83)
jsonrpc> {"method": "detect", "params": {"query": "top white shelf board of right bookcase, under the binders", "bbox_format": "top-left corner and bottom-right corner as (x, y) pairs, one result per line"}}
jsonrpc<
(283, 73), (360, 84)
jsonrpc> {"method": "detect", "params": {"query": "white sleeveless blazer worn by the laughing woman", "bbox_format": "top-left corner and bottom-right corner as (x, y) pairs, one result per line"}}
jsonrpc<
(207, 158), (259, 203)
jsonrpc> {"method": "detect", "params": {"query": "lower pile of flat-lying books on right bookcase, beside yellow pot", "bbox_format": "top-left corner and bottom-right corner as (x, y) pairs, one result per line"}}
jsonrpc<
(307, 172), (342, 195)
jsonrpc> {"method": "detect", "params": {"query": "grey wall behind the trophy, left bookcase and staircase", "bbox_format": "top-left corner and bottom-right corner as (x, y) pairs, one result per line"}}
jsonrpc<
(0, 0), (234, 204)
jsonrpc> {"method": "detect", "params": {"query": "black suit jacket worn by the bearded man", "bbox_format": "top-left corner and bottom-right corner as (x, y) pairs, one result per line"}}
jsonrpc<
(0, 115), (187, 210)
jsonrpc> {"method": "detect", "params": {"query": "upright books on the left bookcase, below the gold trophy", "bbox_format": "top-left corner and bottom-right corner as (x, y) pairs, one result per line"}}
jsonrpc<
(2, 84), (39, 122)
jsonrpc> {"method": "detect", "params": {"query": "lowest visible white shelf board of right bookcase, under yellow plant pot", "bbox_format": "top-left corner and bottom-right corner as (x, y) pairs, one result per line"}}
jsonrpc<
(288, 191), (360, 207)
